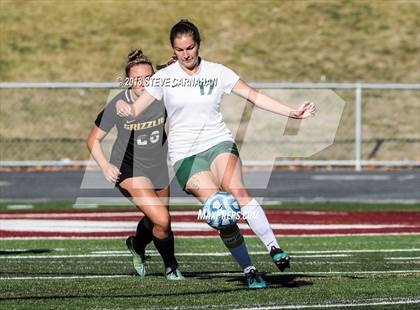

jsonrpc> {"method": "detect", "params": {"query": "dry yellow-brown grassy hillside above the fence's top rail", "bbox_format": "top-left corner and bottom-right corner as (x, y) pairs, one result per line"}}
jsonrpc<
(0, 0), (420, 82)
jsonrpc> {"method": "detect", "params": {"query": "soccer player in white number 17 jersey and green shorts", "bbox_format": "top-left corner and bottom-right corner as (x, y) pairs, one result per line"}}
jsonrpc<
(116, 20), (315, 288)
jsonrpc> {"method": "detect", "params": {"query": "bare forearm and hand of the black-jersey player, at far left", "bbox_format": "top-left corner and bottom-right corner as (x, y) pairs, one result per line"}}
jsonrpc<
(86, 125), (121, 183)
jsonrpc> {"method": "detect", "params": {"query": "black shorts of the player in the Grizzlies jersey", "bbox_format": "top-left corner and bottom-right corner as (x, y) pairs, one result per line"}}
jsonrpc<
(115, 162), (170, 195)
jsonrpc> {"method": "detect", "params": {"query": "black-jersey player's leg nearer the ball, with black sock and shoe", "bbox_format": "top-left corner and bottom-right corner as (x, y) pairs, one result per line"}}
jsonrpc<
(120, 177), (183, 280)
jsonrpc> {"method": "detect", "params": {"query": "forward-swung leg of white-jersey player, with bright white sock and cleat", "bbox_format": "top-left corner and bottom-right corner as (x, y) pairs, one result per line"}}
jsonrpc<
(210, 153), (290, 271)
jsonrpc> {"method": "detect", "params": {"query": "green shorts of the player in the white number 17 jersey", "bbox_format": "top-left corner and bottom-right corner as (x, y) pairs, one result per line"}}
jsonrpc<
(174, 141), (239, 190)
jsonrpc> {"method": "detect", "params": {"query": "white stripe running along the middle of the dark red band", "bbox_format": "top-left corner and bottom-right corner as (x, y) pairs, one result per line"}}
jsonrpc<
(0, 219), (420, 233)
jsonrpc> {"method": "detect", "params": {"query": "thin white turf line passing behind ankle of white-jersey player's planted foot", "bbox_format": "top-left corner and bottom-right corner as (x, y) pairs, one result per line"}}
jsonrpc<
(0, 270), (420, 280)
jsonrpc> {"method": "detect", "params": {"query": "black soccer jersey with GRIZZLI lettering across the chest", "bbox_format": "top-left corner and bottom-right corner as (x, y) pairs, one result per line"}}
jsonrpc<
(95, 89), (167, 168)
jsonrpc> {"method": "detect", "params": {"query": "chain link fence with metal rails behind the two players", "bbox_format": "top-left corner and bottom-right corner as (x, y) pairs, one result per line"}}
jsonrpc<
(0, 83), (420, 167)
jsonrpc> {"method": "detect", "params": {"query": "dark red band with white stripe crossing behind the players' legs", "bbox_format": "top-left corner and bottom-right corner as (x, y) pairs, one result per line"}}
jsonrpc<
(0, 209), (420, 238)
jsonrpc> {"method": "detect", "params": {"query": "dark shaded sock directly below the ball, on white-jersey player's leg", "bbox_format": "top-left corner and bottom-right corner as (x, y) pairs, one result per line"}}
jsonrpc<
(220, 225), (253, 270)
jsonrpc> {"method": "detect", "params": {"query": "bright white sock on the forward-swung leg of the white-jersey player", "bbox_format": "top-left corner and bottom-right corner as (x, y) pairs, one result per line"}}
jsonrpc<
(241, 198), (280, 251)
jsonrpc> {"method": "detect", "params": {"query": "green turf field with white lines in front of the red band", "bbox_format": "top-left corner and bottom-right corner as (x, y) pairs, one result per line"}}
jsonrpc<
(0, 235), (420, 309)
